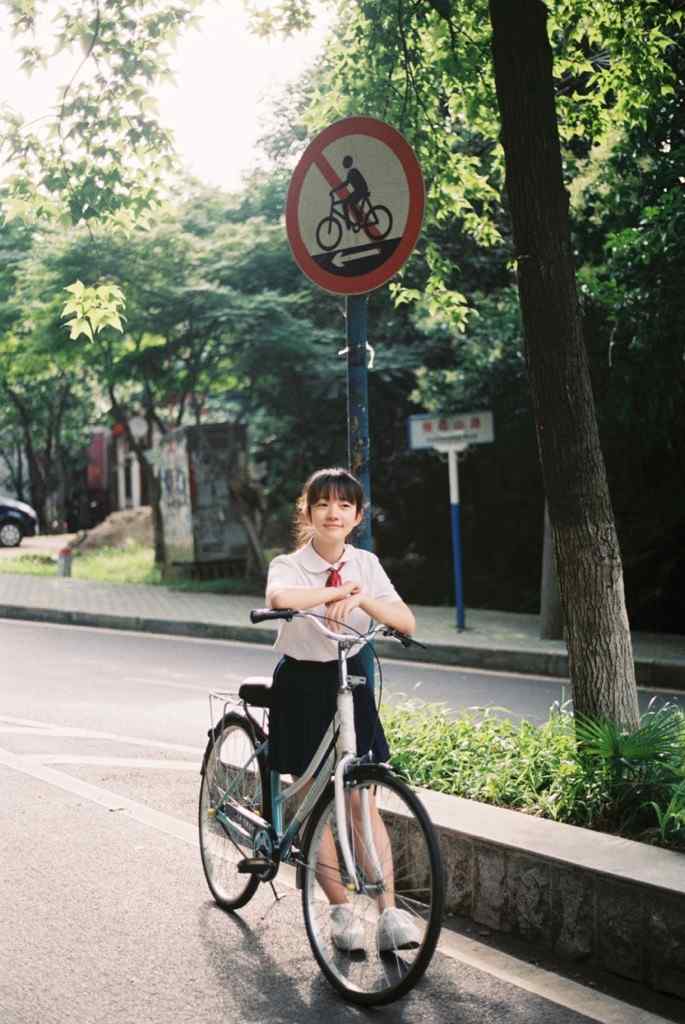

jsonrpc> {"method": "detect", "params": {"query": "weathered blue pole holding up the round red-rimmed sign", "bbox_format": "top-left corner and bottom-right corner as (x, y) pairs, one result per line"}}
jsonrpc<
(345, 295), (373, 551)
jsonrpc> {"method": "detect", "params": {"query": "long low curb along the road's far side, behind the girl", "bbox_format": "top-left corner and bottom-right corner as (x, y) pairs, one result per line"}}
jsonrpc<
(0, 604), (685, 691)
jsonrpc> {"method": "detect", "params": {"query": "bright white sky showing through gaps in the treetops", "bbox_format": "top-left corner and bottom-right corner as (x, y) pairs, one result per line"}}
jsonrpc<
(0, 0), (326, 190)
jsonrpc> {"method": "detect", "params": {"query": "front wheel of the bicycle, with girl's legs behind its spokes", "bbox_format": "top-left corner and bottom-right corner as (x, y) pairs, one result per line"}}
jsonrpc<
(302, 766), (443, 1006)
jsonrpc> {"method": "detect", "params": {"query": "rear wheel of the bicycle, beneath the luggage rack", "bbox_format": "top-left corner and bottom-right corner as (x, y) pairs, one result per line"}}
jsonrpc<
(199, 713), (268, 910)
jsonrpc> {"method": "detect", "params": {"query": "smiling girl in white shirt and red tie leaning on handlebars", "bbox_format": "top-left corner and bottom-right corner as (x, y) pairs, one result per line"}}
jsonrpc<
(266, 468), (419, 951)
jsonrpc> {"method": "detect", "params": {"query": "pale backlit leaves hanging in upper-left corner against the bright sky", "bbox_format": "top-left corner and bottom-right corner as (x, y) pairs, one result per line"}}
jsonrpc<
(1, 0), (201, 224)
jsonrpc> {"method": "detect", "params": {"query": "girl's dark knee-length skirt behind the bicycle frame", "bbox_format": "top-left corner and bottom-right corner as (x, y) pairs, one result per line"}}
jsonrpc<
(269, 654), (390, 775)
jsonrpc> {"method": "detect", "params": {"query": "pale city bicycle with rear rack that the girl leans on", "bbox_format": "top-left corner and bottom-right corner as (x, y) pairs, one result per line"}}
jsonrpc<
(199, 609), (444, 1006)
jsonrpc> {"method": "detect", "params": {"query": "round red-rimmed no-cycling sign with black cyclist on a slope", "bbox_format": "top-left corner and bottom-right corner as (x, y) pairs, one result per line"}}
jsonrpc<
(286, 117), (424, 295)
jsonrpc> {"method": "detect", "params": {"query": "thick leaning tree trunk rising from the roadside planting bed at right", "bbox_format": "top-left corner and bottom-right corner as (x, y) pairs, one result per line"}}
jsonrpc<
(489, 0), (639, 728)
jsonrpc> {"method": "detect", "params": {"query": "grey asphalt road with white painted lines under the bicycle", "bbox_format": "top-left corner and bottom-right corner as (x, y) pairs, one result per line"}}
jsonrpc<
(0, 622), (679, 1024)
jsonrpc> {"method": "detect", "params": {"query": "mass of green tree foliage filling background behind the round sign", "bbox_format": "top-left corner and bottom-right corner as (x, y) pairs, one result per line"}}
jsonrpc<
(0, 0), (685, 628)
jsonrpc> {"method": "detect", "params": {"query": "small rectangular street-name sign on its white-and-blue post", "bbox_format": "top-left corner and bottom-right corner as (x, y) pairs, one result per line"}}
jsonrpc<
(408, 412), (495, 631)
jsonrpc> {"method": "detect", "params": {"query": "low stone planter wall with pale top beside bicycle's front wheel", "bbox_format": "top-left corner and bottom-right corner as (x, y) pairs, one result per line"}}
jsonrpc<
(413, 790), (685, 999)
